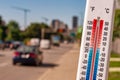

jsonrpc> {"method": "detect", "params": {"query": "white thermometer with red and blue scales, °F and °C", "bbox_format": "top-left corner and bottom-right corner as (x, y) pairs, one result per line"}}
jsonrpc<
(76, 0), (115, 80)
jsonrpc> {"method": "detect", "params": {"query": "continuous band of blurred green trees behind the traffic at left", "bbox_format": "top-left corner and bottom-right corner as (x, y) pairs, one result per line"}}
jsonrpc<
(0, 17), (51, 42)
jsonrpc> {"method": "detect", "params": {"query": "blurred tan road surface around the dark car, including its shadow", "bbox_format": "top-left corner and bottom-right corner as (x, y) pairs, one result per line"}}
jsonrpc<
(0, 44), (73, 80)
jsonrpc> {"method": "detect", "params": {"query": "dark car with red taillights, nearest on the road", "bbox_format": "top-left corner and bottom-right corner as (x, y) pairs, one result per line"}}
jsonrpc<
(13, 46), (43, 66)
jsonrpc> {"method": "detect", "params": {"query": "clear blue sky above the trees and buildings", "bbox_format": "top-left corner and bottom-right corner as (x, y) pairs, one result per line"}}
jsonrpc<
(0, 0), (86, 28)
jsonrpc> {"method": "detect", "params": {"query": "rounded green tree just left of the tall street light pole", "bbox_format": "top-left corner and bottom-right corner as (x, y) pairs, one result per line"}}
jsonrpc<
(6, 20), (20, 40)
